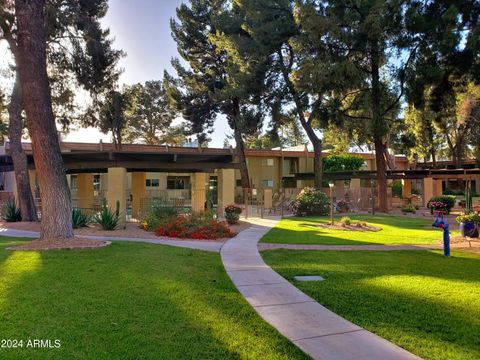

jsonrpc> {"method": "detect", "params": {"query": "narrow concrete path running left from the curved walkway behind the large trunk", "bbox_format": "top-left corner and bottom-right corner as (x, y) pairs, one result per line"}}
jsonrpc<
(0, 228), (223, 252)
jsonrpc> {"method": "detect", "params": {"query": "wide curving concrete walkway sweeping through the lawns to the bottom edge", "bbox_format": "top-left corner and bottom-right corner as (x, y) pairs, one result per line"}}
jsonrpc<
(220, 219), (418, 360)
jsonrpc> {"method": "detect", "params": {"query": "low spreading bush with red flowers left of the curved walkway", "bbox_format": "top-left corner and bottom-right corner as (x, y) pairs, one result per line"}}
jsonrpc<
(155, 212), (235, 240)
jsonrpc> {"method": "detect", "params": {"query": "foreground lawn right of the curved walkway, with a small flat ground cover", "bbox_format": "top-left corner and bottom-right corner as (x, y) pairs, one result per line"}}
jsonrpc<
(262, 250), (480, 360)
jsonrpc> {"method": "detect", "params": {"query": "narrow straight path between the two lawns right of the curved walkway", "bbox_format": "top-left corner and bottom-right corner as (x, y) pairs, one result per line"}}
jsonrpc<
(258, 241), (480, 251)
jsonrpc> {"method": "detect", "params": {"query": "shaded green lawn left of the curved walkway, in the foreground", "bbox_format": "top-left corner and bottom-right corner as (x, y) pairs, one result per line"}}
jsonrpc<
(0, 237), (306, 360)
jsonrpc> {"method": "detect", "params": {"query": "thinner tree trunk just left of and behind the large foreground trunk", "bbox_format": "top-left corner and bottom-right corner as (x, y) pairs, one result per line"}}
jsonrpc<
(8, 73), (38, 221)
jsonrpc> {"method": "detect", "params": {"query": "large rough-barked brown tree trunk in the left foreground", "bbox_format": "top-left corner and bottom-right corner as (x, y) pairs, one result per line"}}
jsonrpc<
(15, 0), (73, 239)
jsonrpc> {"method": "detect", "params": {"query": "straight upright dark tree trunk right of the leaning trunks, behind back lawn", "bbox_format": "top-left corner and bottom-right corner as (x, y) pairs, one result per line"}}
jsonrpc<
(371, 42), (388, 212)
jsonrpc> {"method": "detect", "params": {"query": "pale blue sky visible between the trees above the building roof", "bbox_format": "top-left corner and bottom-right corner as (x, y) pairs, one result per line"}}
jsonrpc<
(66, 0), (230, 147)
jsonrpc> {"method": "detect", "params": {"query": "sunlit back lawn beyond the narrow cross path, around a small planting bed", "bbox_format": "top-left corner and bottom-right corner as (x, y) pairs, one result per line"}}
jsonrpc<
(260, 215), (456, 245)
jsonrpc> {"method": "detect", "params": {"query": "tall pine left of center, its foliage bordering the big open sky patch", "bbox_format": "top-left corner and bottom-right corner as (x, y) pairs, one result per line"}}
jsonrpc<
(164, 0), (264, 188)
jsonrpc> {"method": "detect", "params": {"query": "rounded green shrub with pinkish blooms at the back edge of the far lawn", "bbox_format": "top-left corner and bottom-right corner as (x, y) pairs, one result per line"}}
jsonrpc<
(291, 187), (330, 216)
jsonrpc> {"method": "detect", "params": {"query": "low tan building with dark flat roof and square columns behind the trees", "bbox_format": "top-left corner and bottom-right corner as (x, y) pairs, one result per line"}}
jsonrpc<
(0, 142), (480, 218)
